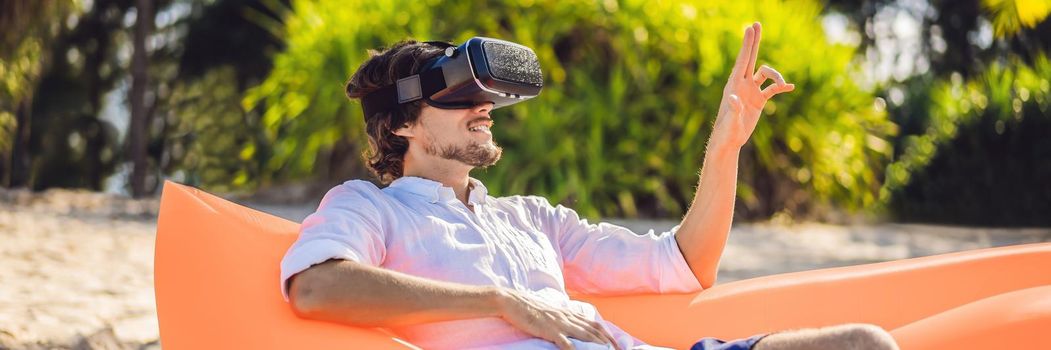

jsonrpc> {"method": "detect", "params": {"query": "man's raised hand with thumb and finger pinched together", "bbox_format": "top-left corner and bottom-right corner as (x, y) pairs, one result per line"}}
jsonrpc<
(712, 22), (796, 147)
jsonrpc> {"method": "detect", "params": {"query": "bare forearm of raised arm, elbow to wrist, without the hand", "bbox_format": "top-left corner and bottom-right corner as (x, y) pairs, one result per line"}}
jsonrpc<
(676, 139), (741, 288)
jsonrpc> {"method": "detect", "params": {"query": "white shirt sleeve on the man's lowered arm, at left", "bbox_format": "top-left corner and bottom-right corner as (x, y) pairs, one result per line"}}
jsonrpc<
(281, 181), (387, 302)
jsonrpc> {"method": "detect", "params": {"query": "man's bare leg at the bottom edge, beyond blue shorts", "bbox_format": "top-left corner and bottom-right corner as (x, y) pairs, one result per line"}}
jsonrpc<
(753, 324), (898, 350)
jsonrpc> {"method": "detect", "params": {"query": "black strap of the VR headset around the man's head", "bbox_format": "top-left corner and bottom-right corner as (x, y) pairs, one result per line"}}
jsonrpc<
(362, 67), (446, 118)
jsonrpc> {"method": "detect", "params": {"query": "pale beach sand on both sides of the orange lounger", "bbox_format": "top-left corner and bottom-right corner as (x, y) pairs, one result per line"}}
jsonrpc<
(0, 189), (1051, 349)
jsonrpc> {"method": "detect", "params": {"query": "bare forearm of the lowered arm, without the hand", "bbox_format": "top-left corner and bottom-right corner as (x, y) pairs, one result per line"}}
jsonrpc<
(290, 260), (501, 327)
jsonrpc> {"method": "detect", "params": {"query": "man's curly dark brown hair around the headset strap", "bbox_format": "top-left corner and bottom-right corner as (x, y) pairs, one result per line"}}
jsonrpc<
(347, 40), (445, 184)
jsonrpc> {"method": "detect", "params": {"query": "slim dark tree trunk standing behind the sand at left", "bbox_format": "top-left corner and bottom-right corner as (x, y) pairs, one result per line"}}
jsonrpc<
(128, 0), (153, 198)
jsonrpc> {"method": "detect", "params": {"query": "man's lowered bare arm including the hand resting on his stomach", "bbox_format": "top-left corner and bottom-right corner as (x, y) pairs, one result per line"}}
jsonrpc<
(289, 260), (616, 349)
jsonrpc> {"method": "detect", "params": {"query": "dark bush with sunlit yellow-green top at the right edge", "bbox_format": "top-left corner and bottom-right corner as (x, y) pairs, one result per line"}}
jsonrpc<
(881, 56), (1051, 226)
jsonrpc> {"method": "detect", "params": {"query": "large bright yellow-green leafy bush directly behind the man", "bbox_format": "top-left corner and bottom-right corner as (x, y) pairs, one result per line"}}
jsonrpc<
(244, 0), (894, 217)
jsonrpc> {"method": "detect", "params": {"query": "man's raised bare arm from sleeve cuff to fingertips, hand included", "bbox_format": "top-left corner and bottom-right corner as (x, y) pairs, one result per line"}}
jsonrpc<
(676, 22), (796, 288)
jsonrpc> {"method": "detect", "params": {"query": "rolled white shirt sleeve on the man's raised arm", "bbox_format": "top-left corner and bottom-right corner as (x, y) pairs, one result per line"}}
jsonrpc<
(531, 197), (702, 295)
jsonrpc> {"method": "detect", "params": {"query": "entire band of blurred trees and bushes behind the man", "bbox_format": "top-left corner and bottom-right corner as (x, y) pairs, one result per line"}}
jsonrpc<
(0, 0), (1051, 226)
